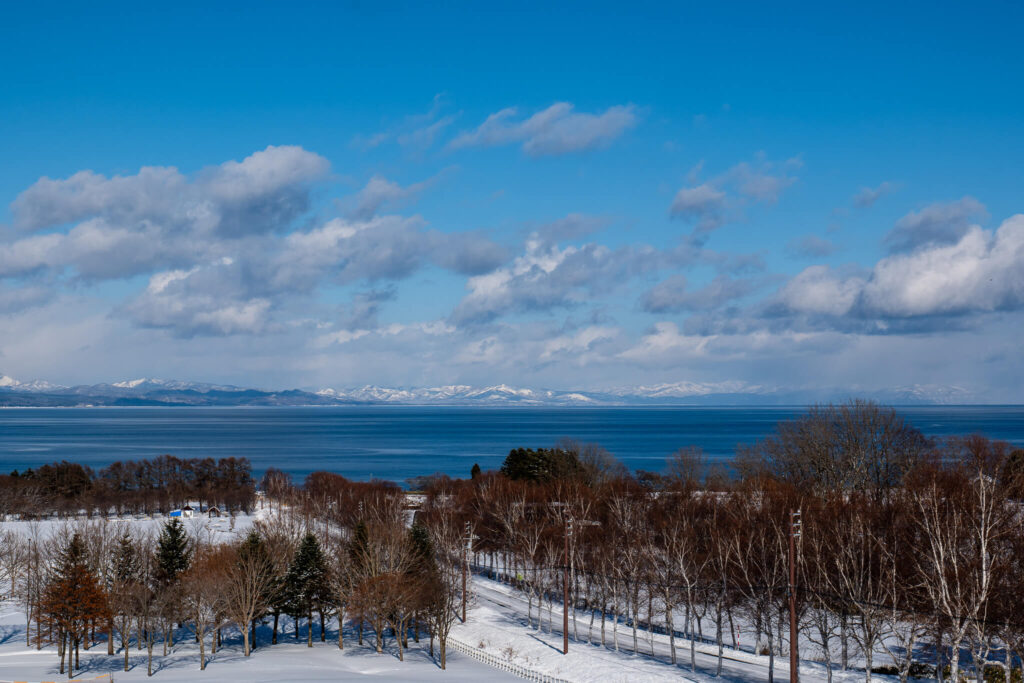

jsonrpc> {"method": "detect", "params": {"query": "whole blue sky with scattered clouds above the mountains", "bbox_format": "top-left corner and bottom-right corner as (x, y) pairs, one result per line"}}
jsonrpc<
(0, 3), (1024, 401)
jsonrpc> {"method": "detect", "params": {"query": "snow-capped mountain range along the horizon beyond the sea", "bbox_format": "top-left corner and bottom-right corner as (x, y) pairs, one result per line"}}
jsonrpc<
(0, 375), (982, 407)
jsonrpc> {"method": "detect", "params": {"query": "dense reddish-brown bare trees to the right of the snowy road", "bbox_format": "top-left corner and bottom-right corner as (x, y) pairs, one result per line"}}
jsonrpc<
(292, 402), (1011, 681)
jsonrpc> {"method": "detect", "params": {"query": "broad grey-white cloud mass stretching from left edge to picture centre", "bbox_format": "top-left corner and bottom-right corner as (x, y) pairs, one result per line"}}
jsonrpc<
(0, 146), (509, 337)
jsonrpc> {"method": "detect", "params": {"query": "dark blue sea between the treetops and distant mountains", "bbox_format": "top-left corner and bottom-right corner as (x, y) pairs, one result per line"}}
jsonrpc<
(0, 405), (1024, 482)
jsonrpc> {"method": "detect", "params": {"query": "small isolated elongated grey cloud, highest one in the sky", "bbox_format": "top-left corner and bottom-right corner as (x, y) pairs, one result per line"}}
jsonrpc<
(449, 102), (637, 157)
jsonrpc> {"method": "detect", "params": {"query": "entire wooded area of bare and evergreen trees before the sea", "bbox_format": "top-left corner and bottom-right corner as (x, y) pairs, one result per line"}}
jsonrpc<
(0, 402), (1024, 681)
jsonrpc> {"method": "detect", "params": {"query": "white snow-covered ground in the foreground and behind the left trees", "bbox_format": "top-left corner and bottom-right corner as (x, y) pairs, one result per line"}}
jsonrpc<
(0, 510), (905, 683)
